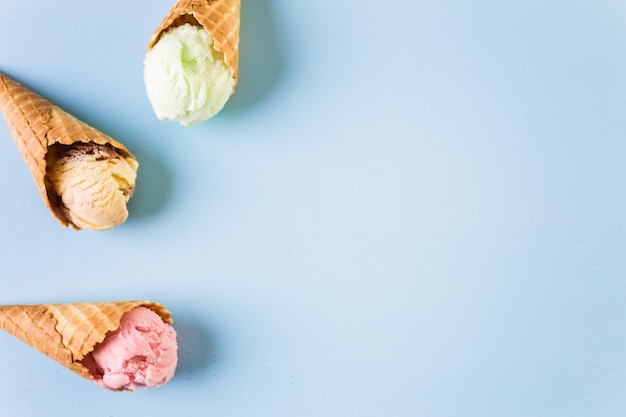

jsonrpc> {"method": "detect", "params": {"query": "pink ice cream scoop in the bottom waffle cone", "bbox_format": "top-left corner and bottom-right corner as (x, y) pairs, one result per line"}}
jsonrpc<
(83, 307), (178, 391)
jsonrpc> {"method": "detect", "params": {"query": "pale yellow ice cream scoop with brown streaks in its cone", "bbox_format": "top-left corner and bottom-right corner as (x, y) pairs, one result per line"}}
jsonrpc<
(46, 143), (138, 230)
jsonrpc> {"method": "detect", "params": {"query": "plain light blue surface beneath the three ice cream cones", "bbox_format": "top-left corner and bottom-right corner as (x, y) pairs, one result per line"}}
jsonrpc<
(0, 0), (626, 417)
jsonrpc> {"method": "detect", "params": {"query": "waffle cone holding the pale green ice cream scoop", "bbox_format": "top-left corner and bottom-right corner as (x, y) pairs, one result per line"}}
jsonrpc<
(148, 0), (241, 88)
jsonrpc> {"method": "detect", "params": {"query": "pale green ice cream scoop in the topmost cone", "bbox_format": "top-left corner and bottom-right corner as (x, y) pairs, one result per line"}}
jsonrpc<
(144, 23), (235, 126)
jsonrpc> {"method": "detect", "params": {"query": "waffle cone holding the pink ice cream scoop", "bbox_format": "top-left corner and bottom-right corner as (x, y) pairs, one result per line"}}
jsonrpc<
(0, 301), (172, 379)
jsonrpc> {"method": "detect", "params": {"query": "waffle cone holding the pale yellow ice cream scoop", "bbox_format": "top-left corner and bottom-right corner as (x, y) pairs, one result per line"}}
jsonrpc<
(0, 73), (134, 229)
